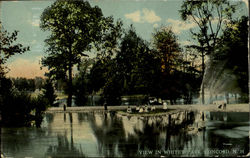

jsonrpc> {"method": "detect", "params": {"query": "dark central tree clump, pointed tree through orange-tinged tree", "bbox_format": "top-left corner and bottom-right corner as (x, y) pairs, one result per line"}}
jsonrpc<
(88, 27), (200, 105)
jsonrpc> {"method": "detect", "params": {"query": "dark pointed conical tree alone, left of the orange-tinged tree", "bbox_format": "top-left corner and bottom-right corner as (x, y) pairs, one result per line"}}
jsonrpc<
(115, 27), (157, 95)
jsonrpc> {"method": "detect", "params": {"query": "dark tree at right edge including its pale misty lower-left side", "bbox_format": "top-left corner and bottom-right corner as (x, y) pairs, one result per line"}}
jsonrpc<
(204, 16), (248, 102)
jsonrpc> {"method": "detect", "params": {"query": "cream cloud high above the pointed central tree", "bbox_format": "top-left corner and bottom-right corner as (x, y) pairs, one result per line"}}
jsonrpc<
(125, 8), (161, 23)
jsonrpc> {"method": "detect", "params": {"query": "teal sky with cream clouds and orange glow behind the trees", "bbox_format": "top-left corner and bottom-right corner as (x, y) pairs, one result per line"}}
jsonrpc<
(0, 0), (248, 78)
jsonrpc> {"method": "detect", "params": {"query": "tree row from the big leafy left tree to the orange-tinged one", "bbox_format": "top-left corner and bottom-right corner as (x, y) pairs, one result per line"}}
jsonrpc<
(40, 1), (200, 106)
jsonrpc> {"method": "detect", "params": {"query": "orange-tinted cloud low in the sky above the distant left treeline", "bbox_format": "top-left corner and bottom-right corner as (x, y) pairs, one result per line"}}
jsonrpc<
(7, 56), (48, 78)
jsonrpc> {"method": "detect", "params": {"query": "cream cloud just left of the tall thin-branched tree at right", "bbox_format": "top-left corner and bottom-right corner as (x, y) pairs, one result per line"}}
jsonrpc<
(166, 18), (197, 34)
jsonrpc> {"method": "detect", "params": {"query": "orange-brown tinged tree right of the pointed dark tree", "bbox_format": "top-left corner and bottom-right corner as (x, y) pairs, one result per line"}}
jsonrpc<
(153, 27), (182, 104)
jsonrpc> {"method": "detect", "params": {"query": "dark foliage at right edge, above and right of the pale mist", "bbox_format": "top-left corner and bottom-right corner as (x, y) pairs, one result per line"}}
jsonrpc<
(212, 16), (248, 102)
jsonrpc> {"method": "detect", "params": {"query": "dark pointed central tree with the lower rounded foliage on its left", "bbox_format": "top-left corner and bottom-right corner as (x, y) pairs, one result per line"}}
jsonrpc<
(89, 26), (160, 105)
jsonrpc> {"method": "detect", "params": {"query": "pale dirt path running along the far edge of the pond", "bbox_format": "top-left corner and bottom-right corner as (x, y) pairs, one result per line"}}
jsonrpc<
(46, 104), (250, 112)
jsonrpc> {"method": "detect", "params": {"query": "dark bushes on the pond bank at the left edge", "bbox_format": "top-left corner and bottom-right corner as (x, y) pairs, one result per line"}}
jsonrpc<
(0, 77), (48, 126)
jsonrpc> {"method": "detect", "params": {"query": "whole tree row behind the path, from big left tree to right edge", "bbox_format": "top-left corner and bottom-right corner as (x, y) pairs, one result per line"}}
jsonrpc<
(40, 0), (247, 106)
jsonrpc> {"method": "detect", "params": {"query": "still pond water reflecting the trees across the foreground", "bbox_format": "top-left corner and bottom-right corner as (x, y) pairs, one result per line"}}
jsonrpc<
(1, 112), (249, 158)
